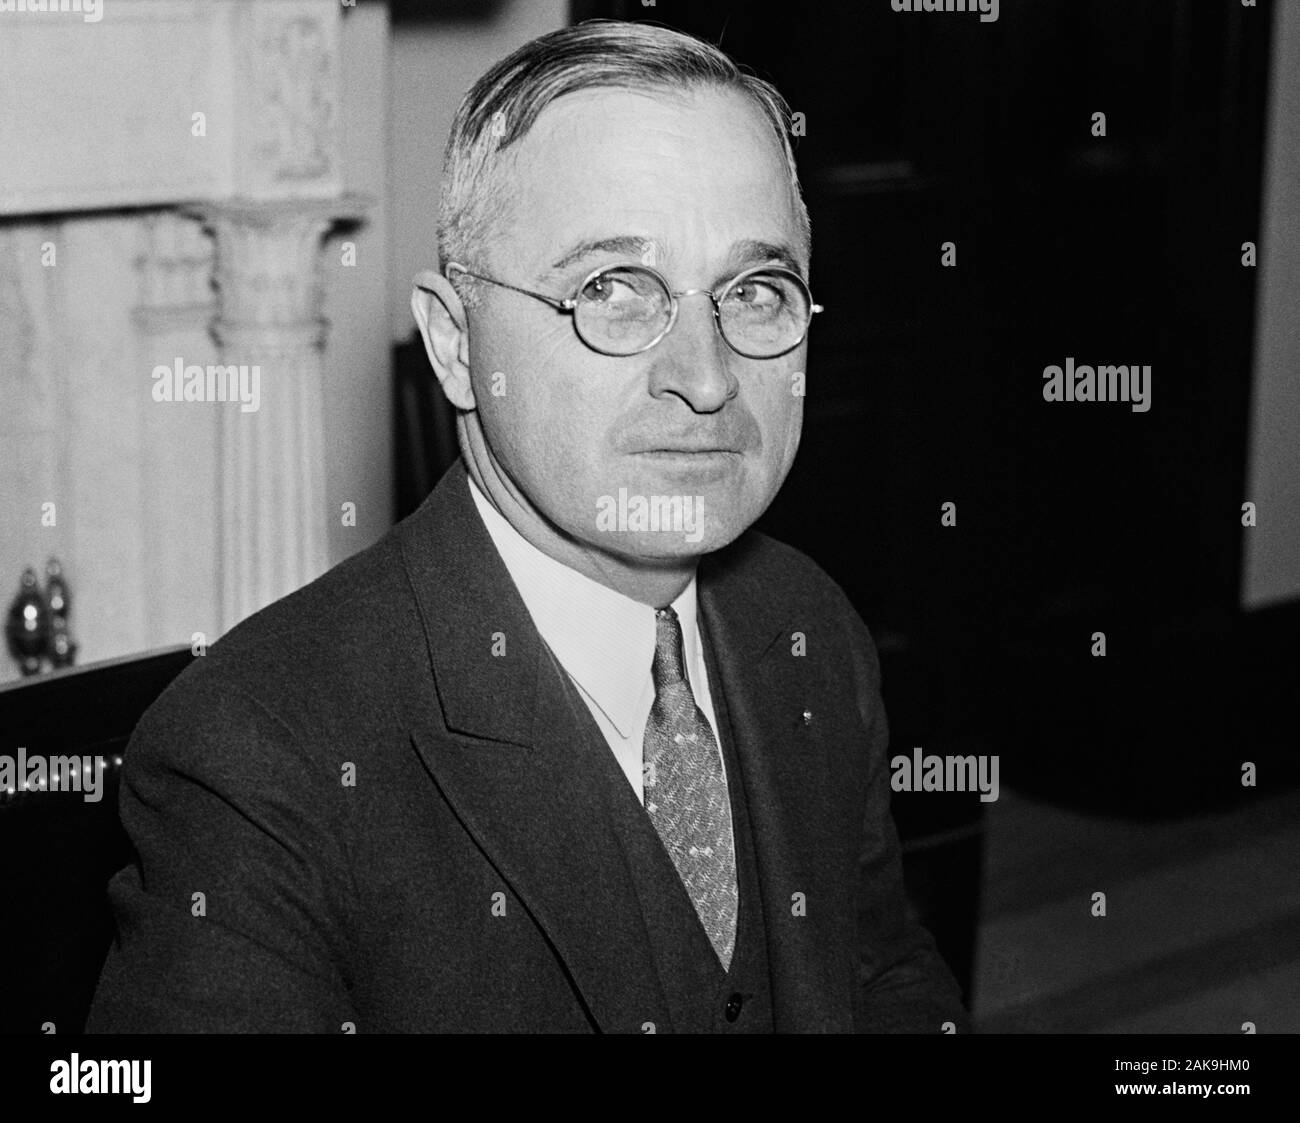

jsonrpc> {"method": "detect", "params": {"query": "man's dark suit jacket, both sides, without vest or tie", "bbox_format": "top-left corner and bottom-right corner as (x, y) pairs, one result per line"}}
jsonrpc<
(87, 463), (967, 1033)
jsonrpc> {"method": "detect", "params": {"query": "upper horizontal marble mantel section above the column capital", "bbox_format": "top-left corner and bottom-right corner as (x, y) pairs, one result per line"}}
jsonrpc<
(0, 0), (351, 214)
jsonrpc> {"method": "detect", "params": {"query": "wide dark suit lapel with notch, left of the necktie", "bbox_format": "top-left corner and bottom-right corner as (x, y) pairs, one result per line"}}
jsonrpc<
(400, 461), (671, 1032)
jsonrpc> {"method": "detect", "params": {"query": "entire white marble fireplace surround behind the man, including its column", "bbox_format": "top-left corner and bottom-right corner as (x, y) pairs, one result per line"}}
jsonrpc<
(0, 0), (369, 677)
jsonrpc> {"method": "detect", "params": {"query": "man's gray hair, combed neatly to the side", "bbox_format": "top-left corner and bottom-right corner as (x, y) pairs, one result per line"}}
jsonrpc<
(438, 19), (811, 304)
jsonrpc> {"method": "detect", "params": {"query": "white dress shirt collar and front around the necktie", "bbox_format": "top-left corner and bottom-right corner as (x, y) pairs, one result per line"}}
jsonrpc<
(469, 477), (727, 803)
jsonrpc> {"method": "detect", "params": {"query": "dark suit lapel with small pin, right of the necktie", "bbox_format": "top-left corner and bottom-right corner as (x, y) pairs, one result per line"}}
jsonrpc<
(699, 546), (855, 1032)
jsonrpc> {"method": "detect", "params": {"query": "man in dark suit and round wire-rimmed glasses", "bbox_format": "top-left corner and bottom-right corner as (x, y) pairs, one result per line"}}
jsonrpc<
(90, 22), (969, 1033)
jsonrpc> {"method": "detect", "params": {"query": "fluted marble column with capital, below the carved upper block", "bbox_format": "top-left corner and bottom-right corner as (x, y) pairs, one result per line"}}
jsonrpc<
(194, 198), (361, 630)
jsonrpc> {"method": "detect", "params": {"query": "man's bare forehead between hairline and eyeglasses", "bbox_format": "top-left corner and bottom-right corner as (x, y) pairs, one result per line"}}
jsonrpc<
(496, 87), (803, 273)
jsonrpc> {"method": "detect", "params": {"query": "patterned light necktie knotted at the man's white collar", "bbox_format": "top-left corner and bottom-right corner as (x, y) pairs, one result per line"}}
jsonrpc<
(642, 608), (737, 970)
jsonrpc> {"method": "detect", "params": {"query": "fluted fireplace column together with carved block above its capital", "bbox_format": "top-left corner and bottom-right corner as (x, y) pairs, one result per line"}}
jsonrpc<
(194, 0), (365, 630)
